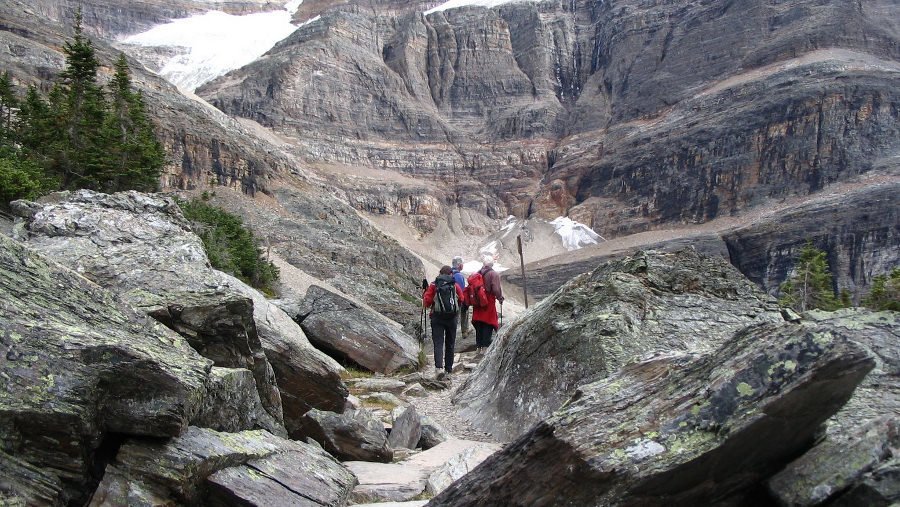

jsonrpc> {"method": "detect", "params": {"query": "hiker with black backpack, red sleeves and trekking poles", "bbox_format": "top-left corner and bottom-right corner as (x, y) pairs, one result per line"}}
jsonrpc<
(423, 266), (465, 379)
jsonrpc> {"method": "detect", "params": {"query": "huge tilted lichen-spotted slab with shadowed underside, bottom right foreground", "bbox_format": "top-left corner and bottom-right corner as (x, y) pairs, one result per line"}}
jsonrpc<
(430, 321), (875, 506)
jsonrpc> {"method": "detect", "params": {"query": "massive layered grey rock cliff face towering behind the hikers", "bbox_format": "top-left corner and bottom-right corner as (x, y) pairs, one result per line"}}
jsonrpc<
(199, 0), (900, 237)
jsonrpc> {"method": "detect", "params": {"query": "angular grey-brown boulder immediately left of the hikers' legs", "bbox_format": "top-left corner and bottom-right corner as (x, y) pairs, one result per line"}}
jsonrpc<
(295, 285), (419, 373)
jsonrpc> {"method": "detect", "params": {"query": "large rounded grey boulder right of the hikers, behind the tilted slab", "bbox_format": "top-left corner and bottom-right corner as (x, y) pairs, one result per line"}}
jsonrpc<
(453, 249), (783, 440)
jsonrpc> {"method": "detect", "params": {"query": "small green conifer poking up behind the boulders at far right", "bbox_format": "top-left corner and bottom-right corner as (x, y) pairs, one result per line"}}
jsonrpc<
(779, 241), (843, 312)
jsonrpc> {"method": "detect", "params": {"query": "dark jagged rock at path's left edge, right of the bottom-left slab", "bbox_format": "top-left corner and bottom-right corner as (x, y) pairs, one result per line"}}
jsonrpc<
(303, 409), (394, 463)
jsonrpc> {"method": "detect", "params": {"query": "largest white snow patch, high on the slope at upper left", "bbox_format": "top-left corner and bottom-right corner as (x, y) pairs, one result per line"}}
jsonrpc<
(121, 0), (314, 91)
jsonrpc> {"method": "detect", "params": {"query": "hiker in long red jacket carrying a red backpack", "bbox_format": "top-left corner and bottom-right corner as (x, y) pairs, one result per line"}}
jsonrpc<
(466, 254), (503, 356)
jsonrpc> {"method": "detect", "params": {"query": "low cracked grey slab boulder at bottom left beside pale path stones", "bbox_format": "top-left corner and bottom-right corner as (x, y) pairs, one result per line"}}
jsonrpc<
(91, 427), (356, 506)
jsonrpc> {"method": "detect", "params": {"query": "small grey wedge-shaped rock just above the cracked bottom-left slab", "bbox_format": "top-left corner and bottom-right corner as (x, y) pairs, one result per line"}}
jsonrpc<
(191, 367), (287, 437)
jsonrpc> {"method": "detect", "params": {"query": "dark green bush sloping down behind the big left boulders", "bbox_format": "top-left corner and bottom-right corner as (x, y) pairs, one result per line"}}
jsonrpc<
(178, 199), (279, 296)
